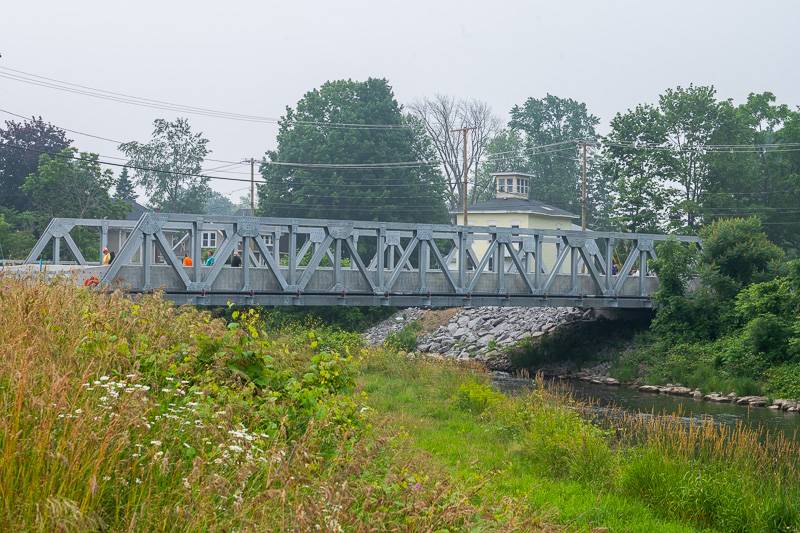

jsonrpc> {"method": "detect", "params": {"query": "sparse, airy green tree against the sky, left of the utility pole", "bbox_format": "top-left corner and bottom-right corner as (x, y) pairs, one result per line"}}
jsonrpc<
(119, 118), (211, 213)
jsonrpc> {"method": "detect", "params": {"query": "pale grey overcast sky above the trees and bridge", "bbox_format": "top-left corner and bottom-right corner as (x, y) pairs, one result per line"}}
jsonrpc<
(0, 0), (800, 200)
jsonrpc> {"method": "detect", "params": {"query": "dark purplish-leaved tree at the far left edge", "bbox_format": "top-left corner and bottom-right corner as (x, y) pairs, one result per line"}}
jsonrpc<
(0, 117), (72, 211)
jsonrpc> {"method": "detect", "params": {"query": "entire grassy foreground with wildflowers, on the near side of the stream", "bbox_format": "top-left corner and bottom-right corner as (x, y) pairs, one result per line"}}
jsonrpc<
(0, 277), (800, 531)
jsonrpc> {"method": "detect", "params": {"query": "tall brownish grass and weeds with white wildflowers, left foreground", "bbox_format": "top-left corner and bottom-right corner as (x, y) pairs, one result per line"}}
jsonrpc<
(0, 277), (520, 531)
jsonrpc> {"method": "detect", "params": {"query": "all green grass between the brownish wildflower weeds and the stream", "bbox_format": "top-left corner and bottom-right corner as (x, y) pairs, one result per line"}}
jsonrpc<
(360, 356), (800, 531)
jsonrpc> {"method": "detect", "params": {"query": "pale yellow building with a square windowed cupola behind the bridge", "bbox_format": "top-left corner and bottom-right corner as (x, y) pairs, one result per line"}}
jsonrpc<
(452, 172), (580, 273)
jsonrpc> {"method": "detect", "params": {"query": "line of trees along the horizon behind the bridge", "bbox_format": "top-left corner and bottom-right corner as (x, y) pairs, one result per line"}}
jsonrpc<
(0, 78), (800, 257)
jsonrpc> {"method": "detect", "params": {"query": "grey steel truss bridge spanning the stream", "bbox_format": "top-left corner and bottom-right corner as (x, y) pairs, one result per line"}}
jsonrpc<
(18, 213), (699, 308)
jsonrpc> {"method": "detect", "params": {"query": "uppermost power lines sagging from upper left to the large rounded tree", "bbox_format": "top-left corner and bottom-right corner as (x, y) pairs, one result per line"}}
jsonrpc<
(0, 67), (412, 130)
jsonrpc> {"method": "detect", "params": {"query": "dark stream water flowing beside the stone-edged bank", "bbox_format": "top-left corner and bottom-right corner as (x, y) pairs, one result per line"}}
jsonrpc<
(492, 375), (800, 440)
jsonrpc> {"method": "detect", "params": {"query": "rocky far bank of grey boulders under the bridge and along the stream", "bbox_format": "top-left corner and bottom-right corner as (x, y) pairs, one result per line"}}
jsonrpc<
(365, 308), (800, 420)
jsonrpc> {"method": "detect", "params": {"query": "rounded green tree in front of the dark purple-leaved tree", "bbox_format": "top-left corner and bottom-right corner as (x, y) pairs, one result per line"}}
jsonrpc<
(22, 148), (126, 218)
